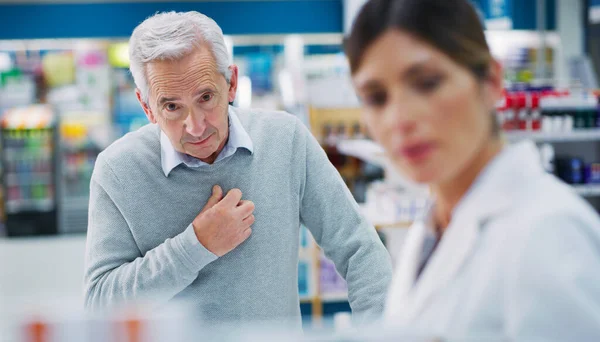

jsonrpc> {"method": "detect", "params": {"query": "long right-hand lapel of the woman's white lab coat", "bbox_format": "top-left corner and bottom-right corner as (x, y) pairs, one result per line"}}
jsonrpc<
(407, 142), (543, 319)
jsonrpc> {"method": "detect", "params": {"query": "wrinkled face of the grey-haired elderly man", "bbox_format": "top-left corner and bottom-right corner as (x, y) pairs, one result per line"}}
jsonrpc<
(137, 45), (237, 163)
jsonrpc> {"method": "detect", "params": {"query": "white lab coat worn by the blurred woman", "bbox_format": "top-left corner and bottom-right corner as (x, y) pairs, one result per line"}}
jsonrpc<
(385, 142), (600, 341)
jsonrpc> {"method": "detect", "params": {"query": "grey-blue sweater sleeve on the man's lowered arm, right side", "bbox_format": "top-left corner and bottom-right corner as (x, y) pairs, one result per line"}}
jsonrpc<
(295, 122), (392, 322)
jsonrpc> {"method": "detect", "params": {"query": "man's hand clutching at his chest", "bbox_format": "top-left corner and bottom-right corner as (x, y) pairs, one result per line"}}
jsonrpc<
(192, 185), (254, 257)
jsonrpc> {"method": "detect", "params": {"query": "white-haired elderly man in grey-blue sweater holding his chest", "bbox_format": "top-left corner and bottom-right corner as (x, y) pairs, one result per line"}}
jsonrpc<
(85, 12), (391, 322)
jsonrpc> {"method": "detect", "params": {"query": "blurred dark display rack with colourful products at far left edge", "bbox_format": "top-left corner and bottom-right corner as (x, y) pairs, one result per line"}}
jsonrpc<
(2, 105), (58, 237)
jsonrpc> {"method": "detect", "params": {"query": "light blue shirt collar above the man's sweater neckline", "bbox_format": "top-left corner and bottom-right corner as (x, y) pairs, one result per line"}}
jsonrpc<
(160, 106), (254, 177)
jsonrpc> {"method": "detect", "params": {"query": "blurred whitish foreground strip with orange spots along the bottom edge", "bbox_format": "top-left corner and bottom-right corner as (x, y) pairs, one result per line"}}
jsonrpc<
(0, 301), (462, 342)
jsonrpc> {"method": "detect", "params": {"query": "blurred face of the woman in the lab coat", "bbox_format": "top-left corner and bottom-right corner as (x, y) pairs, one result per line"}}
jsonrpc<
(353, 30), (502, 184)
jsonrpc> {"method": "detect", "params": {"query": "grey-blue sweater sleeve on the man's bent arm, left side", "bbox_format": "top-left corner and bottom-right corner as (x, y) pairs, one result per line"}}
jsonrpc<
(84, 157), (217, 309)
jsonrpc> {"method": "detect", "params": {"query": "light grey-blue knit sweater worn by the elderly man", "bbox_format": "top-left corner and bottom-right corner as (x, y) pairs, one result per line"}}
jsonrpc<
(85, 109), (392, 322)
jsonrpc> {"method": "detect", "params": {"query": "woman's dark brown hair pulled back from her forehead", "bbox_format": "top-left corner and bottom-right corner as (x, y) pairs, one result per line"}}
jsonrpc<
(344, 0), (493, 79)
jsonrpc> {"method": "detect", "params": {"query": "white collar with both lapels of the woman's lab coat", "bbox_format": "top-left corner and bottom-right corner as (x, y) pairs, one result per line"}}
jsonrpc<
(390, 142), (544, 321)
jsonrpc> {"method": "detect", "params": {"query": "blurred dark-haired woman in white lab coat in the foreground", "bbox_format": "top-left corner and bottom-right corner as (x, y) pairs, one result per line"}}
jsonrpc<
(345, 0), (600, 341)
